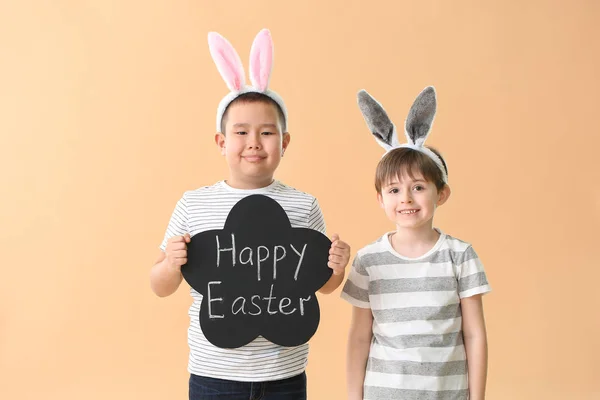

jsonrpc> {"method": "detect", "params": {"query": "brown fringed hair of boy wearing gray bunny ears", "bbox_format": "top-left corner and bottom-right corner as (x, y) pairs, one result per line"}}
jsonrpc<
(375, 146), (448, 193)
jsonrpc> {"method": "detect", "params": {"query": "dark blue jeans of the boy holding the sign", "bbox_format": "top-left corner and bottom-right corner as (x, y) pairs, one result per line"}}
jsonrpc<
(189, 372), (306, 400)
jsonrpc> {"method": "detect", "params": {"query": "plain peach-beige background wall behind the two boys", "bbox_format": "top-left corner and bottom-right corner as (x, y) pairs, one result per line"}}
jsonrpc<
(0, 0), (600, 400)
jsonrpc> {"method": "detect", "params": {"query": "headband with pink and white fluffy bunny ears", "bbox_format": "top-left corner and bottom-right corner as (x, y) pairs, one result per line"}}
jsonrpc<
(208, 29), (287, 132)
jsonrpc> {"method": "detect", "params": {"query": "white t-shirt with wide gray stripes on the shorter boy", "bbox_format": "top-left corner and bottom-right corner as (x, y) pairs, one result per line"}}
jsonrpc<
(341, 232), (491, 400)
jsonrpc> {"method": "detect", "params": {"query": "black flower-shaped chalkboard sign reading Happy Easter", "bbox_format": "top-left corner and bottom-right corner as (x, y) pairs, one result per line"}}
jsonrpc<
(181, 195), (332, 348)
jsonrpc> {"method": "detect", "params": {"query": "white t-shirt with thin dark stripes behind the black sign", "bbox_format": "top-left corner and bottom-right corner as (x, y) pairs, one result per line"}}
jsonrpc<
(160, 181), (325, 382)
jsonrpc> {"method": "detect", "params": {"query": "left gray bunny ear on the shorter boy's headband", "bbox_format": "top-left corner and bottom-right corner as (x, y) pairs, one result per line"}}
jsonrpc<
(357, 90), (398, 150)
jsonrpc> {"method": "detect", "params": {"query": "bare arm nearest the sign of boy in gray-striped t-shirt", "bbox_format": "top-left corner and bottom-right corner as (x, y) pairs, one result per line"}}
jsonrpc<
(346, 307), (373, 400)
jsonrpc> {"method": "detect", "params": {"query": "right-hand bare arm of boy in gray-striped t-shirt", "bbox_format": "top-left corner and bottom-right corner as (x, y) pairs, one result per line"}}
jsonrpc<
(460, 295), (487, 400)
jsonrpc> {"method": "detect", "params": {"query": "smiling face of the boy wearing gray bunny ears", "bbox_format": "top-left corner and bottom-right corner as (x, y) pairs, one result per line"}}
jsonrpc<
(377, 174), (450, 229)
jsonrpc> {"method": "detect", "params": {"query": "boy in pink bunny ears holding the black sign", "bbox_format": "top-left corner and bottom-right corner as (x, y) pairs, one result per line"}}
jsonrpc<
(150, 29), (350, 400)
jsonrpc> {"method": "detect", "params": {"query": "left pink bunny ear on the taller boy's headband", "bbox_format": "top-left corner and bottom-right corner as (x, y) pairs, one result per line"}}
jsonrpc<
(208, 32), (246, 91)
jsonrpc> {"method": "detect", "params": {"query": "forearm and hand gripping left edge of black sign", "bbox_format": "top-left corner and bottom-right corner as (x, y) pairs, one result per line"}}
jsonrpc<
(150, 233), (190, 297)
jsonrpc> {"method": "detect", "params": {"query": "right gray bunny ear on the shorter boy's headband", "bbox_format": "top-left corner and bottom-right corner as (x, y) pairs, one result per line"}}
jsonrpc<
(404, 86), (437, 146)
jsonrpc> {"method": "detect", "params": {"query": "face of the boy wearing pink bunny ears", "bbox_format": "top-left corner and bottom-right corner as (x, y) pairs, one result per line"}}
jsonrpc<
(215, 102), (290, 189)
